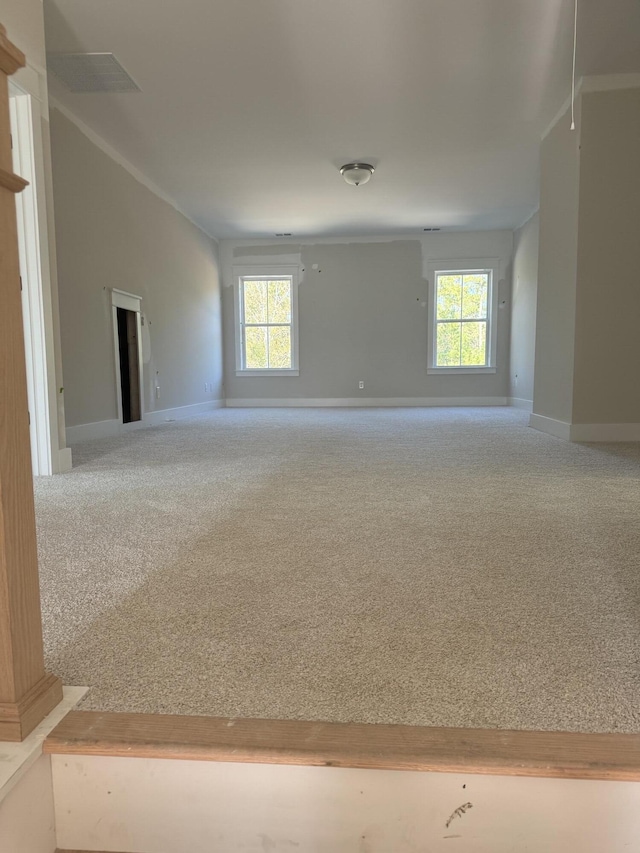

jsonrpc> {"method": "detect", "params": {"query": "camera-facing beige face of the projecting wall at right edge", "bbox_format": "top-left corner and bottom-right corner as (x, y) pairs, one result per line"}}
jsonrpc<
(573, 88), (640, 424)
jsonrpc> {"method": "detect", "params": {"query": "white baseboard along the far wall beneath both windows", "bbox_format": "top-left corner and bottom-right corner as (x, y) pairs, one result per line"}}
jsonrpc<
(226, 397), (507, 409)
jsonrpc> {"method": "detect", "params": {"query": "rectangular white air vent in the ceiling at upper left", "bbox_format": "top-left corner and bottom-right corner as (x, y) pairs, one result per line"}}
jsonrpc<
(47, 53), (140, 93)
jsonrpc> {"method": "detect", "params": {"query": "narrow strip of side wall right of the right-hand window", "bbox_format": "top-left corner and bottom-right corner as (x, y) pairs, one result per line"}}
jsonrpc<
(509, 213), (540, 404)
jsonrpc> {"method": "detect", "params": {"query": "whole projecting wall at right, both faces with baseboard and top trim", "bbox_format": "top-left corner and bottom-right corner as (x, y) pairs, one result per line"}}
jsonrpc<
(531, 86), (640, 441)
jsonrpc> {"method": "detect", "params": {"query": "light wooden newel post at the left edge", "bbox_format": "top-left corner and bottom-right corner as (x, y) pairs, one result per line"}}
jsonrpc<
(0, 25), (62, 741)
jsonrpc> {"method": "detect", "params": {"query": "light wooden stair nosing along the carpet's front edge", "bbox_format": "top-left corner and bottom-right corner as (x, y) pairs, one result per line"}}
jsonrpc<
(44, 711), (640, 781)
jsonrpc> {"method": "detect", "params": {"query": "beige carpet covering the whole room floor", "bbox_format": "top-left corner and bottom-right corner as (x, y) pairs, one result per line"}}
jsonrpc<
(36, 408), (640, 731)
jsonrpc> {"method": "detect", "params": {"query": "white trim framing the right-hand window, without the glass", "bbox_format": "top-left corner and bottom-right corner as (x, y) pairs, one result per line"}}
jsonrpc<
(427, 258), (502, 374)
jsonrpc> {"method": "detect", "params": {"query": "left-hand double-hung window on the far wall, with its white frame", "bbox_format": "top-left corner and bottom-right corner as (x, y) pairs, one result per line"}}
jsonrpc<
(236, 268), (298, 376)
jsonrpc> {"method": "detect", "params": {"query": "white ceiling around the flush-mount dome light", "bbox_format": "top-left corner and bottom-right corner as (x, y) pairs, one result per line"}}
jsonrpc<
(45, 0), (640, 238)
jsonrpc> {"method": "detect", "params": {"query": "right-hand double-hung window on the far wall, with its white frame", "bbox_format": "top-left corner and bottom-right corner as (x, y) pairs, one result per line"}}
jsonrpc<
(427, 261), (496, 373)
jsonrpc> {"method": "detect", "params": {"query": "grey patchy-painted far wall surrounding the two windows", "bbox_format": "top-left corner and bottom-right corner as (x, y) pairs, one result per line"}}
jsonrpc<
(220, 231), (512, 402)
